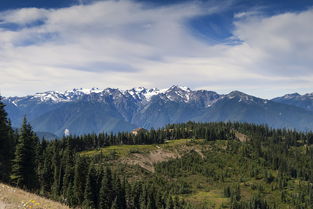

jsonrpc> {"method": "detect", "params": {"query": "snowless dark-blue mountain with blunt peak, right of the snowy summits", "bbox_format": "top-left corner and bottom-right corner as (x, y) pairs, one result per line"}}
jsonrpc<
(199, 92), (313, 130)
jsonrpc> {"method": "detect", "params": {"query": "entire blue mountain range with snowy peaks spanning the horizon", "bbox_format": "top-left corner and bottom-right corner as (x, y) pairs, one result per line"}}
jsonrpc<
(2, 85), (313, 136)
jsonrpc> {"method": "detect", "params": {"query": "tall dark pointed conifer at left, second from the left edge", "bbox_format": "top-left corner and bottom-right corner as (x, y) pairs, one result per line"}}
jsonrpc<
(10, 118), (38, 190)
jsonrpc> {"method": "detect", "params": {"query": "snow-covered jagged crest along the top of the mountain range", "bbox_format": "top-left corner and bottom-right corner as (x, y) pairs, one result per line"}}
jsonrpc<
(5, 85), (218, 106)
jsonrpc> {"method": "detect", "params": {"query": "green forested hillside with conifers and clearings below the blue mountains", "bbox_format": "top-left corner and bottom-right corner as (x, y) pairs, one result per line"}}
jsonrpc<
(0, 97), (313, 209)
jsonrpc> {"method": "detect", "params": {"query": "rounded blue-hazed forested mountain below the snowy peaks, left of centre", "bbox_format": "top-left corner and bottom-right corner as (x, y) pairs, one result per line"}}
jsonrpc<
(31, 102), (135, 136)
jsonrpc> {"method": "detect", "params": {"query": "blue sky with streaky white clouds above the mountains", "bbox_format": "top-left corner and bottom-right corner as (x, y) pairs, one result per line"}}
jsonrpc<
(0, 0), (313, 98)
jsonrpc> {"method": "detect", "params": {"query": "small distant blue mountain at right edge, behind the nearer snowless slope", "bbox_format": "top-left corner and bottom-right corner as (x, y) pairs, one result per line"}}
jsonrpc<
(272, 93), (313, 112)
